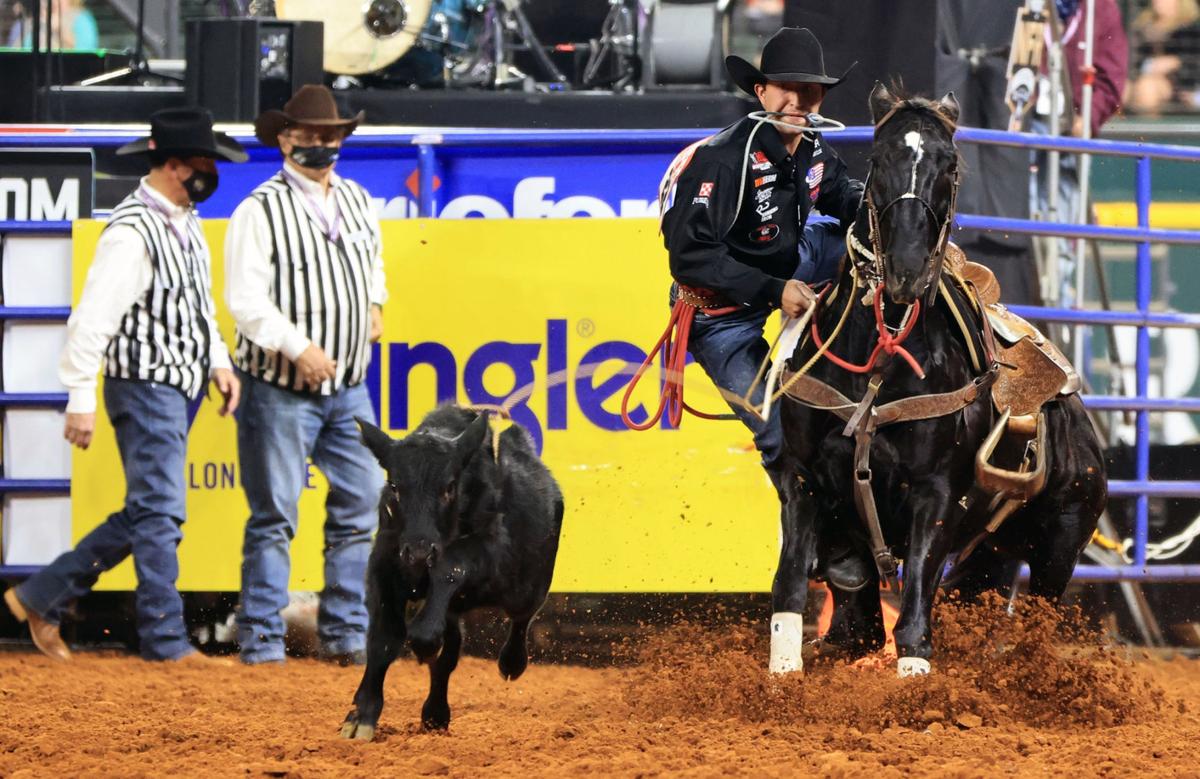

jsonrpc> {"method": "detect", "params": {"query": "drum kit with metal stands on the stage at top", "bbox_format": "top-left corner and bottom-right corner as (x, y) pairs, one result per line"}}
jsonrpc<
(263, 0), (721, 91)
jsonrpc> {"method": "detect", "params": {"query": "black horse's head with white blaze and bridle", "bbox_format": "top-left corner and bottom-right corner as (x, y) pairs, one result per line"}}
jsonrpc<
(866, 84), (959, 304)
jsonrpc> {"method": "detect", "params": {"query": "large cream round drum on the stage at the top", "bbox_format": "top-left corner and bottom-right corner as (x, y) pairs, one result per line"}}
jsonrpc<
(275, 0), (433, 76)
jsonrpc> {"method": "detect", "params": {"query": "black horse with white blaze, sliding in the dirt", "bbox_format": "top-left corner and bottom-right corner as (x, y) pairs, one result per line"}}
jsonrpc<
(773, 84), (1106, 676)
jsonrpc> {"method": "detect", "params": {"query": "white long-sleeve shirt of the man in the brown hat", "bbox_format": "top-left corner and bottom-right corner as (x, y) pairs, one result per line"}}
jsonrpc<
(224, 162), (388, 361)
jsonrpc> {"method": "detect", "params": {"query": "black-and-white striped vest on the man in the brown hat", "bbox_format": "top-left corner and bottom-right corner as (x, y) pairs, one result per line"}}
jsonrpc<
(234, 172), (379, 395)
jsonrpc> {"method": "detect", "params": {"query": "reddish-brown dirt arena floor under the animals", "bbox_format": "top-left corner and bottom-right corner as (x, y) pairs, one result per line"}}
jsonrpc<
(0, 592), (1200, 779)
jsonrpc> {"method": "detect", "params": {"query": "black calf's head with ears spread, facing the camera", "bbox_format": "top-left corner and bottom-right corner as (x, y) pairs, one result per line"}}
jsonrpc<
(359, 415), (488, 585)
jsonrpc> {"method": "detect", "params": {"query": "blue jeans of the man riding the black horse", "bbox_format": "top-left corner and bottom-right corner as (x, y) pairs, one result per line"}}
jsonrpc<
(688, 217), (846, 468)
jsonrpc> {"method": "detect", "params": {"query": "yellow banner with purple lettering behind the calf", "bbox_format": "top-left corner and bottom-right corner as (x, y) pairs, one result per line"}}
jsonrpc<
(72, 220), (779, 592)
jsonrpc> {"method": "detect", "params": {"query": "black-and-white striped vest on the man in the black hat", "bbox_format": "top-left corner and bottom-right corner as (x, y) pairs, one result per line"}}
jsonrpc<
(104, 187), (220, 399)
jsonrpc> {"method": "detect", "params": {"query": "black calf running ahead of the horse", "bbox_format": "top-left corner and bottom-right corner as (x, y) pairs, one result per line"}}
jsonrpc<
(342, 406), (563, 739)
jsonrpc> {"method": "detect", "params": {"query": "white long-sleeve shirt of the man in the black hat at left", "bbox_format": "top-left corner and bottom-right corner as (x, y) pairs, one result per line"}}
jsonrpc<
(59, 178), (233, 414)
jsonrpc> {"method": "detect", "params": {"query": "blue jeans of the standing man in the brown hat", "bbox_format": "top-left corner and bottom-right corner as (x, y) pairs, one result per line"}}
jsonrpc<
(236, 371), (383, 664)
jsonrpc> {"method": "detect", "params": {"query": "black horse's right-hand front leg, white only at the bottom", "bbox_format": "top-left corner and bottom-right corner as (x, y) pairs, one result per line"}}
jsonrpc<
(895, 477), (956, 677)
